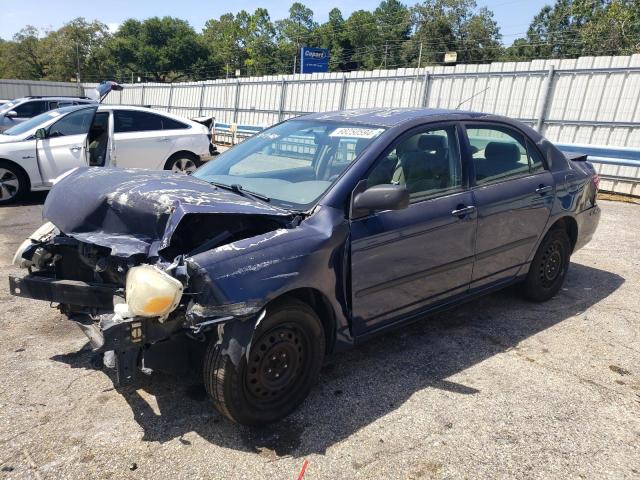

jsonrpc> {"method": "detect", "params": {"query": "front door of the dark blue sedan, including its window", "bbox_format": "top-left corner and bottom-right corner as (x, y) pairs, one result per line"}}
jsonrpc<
(351, 124), (476, 335)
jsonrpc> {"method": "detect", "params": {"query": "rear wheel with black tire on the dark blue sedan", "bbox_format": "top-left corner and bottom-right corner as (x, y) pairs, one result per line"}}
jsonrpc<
(522, 228), (571, 302)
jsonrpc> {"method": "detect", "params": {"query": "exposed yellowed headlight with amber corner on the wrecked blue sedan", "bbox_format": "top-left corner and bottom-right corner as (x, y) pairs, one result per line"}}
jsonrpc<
(126, 265), (184, 320)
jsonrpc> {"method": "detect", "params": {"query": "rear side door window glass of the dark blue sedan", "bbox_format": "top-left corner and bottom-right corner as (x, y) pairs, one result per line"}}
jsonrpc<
(467, 126), (544, 185)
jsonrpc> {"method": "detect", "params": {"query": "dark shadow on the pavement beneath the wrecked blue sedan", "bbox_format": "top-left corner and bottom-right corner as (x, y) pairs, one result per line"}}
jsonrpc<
(55, 263), (624, 457)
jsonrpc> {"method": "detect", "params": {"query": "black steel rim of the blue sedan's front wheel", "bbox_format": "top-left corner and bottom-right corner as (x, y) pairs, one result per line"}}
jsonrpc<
(245, 325), (309, 407)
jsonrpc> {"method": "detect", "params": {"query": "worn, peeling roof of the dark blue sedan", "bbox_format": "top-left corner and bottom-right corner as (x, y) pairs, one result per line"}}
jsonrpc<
(300, 108), (486, 127)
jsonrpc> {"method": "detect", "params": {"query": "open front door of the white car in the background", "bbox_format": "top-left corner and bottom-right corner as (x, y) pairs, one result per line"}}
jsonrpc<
(38, 108), (96, 184)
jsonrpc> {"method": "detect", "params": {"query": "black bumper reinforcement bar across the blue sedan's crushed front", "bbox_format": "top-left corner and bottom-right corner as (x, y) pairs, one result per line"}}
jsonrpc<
(9, 275), (117, 309)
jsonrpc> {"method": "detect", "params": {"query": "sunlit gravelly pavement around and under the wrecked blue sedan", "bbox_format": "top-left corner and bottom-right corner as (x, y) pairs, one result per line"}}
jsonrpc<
(0, 198), (640, 479)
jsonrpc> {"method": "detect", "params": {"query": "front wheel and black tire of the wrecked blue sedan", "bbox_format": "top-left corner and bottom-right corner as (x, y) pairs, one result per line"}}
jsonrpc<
(203, 300), (325, 426)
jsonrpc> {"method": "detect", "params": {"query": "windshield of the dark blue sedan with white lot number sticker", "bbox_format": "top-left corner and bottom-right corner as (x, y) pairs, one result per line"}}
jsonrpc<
(194, 120), (385, 210)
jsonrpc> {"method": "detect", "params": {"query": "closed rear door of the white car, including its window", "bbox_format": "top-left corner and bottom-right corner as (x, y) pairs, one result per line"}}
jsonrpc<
(112, 109), (172, 169)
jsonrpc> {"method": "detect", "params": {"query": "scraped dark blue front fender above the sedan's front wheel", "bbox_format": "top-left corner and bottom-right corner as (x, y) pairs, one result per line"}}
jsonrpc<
(180, 209), (349, 366)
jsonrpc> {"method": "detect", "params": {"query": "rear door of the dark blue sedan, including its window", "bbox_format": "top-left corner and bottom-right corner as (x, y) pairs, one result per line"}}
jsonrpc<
(465, 123), (555, 289)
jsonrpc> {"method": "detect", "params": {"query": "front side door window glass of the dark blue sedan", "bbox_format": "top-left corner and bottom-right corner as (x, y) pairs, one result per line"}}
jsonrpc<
(367, 126), (462, 199)
